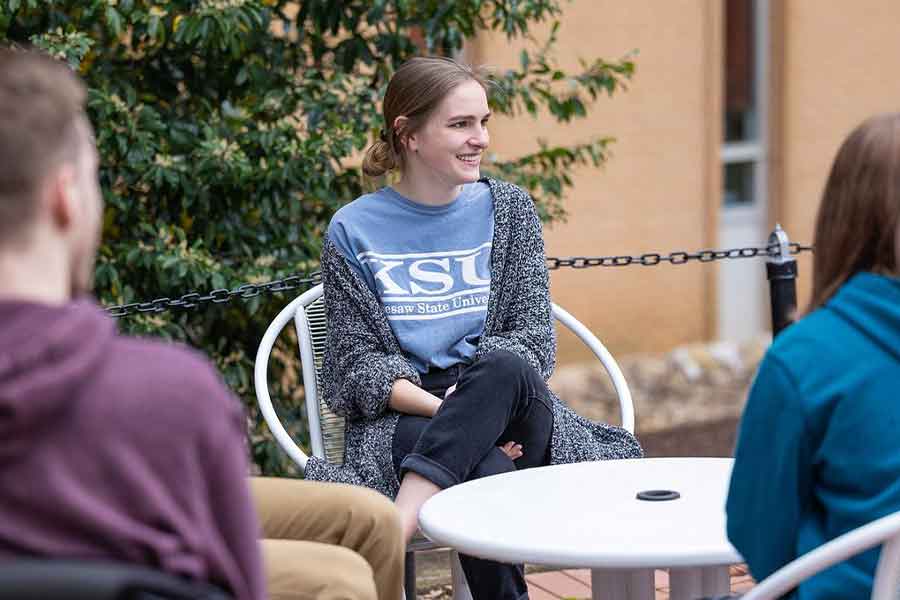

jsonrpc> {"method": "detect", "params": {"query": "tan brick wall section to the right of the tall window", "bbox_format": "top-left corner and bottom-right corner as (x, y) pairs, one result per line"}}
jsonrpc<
(773, 0), (900, 310)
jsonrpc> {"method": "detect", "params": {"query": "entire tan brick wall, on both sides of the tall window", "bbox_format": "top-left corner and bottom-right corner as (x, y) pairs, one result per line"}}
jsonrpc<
(470, 0), (900, 362)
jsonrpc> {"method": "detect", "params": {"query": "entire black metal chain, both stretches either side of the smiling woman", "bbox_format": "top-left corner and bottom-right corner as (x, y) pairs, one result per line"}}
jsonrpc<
(106, 242), (813, 318)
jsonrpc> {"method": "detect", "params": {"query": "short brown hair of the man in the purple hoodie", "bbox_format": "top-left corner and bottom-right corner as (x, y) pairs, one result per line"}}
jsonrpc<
(0, 48), (86, 243)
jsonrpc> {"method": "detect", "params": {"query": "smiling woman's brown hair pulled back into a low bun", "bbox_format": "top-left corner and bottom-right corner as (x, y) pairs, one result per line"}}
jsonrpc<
(362, 56), (487, 177)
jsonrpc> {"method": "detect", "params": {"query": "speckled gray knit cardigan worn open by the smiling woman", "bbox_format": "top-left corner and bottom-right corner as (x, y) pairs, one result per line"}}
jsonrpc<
(306, 179), (642, 498)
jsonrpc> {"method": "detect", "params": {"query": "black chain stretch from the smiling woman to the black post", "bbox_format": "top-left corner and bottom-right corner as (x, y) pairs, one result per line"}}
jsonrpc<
(547, 242), (813, 271)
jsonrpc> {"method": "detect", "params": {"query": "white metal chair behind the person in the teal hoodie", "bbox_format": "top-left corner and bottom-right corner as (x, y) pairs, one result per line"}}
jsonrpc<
(741, 512), (900, 600)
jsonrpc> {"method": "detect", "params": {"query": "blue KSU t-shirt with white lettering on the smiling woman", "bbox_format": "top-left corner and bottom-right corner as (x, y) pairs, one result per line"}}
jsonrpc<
(328, 181), (494, 373)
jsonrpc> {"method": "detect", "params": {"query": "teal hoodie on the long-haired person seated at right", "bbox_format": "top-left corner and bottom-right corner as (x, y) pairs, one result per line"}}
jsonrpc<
(726, 273), (900, 600)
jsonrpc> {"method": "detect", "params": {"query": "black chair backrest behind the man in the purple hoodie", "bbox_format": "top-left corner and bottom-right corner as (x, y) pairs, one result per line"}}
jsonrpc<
(0, 559), (230, 600)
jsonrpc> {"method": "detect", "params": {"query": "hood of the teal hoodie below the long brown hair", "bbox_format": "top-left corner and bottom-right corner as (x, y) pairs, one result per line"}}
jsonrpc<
(826, 273), (900, 362)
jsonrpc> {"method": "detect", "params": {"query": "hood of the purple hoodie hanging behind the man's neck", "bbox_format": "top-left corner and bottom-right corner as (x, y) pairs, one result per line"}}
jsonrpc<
(0, 300), (115, 463)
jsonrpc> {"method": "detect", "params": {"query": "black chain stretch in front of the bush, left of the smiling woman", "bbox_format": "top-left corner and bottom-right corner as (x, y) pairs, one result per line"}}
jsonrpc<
(106, 271), (322, 318)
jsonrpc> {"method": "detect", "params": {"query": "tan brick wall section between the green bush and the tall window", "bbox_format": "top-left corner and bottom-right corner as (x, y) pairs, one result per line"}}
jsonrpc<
(470, 0), (721, 361)
